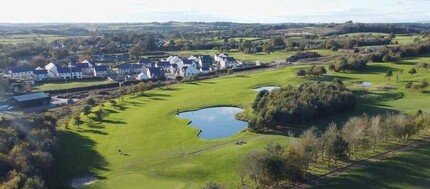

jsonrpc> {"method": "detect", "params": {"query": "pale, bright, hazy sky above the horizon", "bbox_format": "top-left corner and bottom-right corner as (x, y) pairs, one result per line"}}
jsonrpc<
(0, 0), (430, 23)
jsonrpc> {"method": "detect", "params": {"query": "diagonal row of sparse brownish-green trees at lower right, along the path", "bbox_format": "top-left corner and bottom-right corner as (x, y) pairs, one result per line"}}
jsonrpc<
(239, 110), (430, 188)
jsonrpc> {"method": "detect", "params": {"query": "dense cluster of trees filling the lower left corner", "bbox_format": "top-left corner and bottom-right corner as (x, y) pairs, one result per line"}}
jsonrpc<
(0, 115), (58, 189)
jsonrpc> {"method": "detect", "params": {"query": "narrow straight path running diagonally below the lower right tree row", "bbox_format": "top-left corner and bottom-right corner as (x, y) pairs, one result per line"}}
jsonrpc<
(294, 137), (430, 188)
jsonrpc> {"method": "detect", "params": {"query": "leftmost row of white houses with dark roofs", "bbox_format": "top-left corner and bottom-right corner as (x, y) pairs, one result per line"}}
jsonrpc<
(6, 61), (110, 81)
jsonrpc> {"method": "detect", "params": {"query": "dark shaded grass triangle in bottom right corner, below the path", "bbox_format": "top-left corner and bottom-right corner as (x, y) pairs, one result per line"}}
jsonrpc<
(314, 143), (430, 189)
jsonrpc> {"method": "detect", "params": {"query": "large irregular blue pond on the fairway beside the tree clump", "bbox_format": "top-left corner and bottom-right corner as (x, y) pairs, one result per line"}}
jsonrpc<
(178, 107), (248, 139)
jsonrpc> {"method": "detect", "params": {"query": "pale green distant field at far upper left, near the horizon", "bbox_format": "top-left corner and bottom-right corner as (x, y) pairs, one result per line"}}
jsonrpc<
(0, 34), (85, 44)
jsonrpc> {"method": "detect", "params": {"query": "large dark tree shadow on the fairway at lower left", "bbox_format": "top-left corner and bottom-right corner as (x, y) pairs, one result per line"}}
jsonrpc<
(47, 131), (108, 188)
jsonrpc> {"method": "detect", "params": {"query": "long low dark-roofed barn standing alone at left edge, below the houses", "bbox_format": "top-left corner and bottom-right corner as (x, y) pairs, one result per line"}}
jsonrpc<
(13, 92), (51, 108)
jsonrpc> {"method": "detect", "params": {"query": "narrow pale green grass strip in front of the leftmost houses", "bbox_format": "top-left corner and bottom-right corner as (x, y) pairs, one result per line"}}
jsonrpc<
(33, 80), (112, 91)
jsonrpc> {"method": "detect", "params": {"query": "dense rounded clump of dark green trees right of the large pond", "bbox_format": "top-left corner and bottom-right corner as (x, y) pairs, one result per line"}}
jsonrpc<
(249, 82), (356, 131)
